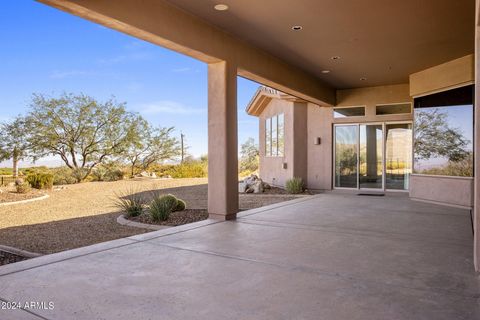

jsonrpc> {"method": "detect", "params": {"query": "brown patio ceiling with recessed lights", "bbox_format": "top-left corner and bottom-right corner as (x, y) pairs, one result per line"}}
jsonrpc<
(168, 0), (475, 89)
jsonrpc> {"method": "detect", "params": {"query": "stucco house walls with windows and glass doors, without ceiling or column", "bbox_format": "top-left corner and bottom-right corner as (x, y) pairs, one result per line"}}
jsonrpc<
(246, 55), (474, 208)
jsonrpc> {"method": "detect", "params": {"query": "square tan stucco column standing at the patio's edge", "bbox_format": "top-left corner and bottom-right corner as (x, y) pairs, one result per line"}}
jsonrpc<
(208, 61), (238, 220)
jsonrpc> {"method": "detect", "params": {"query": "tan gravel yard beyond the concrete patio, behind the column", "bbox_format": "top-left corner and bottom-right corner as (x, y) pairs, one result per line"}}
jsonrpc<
(0, 178), (306, 254)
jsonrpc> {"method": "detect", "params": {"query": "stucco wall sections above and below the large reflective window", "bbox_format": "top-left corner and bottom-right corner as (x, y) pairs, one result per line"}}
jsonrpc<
(410, 55), (475, 207)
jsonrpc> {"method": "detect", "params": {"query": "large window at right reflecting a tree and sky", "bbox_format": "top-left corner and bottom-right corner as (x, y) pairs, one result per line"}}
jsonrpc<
(413, 85), (474, 177)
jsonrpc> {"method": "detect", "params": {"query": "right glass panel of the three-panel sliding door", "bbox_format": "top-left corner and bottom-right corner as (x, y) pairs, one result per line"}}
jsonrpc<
(385, 123), (412, 190)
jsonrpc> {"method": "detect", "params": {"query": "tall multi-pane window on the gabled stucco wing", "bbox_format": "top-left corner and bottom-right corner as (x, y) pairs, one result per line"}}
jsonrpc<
(265, 113), (285, 157)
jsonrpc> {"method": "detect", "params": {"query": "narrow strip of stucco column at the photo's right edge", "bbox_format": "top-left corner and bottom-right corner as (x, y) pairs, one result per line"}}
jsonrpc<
(473, 0), (480, 272)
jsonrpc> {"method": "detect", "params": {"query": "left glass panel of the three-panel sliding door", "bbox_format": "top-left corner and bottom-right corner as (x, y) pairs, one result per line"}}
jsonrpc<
(335, 126), (358, 188)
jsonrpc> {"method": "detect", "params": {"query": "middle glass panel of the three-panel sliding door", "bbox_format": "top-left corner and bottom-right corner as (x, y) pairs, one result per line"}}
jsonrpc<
(359, 125), (383, 189)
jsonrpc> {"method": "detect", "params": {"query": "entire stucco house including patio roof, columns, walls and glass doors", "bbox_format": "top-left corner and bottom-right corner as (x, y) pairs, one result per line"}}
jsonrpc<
(39, 0), (480, 271)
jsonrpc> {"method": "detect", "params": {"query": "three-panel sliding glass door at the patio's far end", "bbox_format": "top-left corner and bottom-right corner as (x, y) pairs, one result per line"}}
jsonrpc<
(334, 123), (412, 190)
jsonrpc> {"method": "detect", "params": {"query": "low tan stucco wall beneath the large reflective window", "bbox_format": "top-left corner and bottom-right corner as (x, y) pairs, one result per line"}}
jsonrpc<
(410, 174), (473, 207)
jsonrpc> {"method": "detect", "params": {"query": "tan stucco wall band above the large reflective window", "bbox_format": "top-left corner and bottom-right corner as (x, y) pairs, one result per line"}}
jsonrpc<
(410, 54), (475, 96)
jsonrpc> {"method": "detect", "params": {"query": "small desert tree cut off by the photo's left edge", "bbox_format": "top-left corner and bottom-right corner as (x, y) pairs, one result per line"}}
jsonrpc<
(0, 116), (31, 177)
